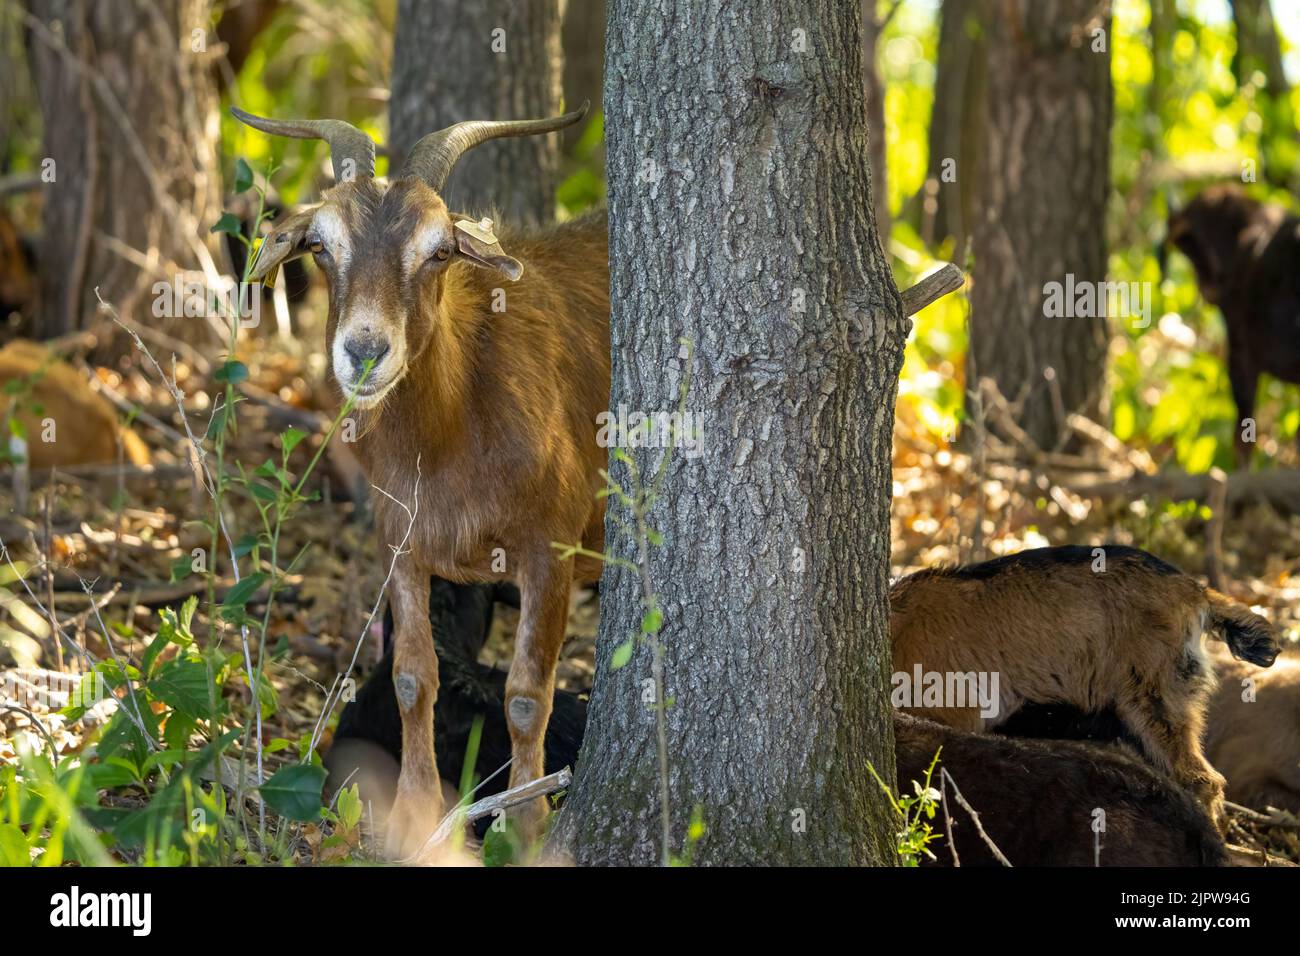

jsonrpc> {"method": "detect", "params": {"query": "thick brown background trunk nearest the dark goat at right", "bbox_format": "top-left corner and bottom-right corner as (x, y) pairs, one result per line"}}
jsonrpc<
(967, 0), (1112, 449)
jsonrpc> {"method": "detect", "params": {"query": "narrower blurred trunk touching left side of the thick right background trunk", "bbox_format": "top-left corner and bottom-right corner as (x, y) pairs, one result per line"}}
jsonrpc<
(919, 0), (985, 254)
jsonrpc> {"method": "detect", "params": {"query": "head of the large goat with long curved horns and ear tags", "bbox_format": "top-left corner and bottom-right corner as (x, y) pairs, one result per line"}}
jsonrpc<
(233, 103), (588, 408)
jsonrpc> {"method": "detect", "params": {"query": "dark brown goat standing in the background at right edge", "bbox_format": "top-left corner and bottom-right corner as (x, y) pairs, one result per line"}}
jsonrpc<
(1160, 185), (1300, 468)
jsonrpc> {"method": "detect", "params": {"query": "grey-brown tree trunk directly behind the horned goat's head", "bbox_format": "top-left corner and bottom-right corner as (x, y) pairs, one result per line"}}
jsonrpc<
(389, 0), (564, 222)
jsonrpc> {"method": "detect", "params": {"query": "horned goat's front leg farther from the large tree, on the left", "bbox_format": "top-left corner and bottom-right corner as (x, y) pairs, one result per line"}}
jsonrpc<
(387, 566), (442, 858)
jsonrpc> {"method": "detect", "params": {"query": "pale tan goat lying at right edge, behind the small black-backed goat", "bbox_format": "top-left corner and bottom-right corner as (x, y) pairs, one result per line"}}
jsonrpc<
(1205, 648), (1300, 814)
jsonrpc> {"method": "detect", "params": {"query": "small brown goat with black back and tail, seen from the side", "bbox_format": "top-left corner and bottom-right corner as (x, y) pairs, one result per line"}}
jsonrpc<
(889, 545), (1278, 825)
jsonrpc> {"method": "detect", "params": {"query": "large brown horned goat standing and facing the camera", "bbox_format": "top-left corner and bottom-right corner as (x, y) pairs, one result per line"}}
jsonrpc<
(235, 105), (610, 856)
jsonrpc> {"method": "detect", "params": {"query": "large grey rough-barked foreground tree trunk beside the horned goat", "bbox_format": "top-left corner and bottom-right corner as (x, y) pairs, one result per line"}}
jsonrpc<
(554, 0), (907, 865)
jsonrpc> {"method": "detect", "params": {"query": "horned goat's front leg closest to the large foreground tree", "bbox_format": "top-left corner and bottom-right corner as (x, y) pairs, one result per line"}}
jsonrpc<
(506, 553), (573, 843)
